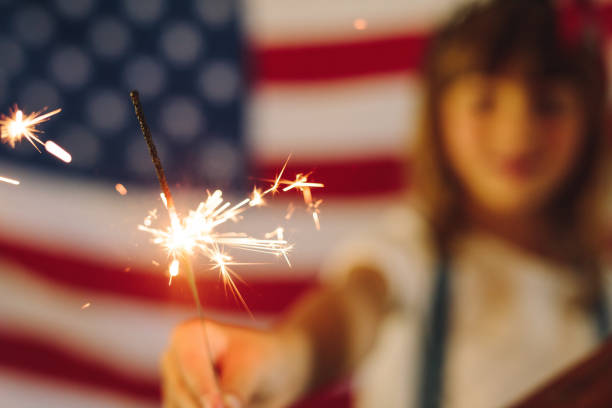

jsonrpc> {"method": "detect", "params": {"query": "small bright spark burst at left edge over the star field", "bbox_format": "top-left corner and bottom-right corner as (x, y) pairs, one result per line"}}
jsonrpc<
(0, 105), (72, 163)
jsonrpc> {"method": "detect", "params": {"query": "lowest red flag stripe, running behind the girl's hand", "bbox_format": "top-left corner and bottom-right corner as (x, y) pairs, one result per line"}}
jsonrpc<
(0, 330), (351, 408)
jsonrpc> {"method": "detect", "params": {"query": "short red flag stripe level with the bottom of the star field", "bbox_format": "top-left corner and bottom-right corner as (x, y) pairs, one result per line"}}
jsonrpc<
(251, 157), (410, 198)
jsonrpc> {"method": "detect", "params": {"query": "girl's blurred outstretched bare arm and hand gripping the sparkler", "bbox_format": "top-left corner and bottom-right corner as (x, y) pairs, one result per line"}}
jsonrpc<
(162, 268), (389, 407)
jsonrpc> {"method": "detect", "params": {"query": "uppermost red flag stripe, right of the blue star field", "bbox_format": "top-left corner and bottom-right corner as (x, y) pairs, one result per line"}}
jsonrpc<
(253, 34), (428, 82)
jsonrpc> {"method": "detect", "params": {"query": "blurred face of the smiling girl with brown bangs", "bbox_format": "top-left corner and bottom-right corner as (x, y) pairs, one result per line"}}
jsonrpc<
(440, 74), (584, 216)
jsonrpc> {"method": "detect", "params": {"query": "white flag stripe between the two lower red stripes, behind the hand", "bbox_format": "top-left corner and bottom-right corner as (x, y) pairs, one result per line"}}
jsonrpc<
(0, 262), (270, 381)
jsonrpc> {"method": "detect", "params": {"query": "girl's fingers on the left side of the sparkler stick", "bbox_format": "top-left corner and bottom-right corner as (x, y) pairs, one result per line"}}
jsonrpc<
(170, 320), (223, 408)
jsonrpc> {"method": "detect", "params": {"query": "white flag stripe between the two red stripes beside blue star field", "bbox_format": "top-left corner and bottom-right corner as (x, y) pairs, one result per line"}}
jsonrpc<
(248, 74), (420, 161)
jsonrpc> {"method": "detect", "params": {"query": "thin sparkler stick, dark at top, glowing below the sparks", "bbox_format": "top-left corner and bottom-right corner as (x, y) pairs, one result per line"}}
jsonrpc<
(130, 90), (221, 400)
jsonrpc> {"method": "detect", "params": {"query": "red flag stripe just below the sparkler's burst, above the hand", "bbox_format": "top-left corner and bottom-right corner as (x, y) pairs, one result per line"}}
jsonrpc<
(0, 238), (316, 313)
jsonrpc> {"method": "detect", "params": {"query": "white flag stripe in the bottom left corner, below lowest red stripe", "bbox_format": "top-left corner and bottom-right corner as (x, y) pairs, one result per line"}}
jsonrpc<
(0, 369), (157, 408)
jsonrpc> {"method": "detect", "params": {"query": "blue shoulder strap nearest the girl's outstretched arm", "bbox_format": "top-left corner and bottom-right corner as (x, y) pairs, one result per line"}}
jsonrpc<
(418, 257), (450, 408)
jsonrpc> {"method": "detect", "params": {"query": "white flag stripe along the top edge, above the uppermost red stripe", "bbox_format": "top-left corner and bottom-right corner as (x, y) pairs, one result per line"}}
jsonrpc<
(244, 0), (474, 46)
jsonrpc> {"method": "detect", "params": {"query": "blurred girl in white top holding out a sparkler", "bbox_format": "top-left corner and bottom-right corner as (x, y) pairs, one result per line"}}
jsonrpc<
(163, 0), (612, 408)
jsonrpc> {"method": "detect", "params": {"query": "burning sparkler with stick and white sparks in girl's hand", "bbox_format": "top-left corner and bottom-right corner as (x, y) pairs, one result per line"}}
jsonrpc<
(130, 91), (323, 402)
